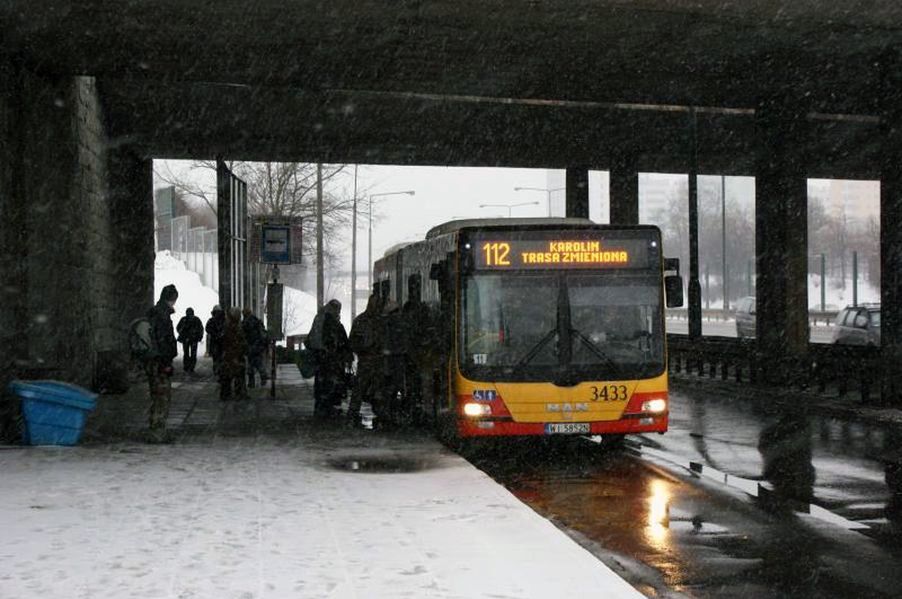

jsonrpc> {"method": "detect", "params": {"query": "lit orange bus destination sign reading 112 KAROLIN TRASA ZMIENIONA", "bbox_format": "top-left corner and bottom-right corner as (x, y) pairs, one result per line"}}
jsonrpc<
(470, 233), (657, 270)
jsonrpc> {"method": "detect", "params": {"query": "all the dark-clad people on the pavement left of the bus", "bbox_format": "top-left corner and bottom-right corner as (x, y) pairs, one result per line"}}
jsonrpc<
(137, 275), (440, 441)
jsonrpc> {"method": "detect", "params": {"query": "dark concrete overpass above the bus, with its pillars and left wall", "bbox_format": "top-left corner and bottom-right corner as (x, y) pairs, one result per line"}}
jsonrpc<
(0, 0), (902, 398)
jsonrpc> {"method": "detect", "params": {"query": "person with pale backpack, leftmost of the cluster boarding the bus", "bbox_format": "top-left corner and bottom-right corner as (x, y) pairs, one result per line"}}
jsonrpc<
(306, 299), (353, 418)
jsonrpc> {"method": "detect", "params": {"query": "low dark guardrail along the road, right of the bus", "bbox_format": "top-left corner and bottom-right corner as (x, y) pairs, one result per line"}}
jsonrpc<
(667, 334), (882, 403)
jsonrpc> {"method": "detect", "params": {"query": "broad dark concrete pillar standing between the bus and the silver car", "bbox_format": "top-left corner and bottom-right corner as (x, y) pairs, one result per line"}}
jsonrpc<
(755, 100), (809, 383)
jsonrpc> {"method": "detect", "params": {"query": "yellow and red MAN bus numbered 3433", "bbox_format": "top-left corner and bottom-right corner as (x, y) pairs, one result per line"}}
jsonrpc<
(375, 218), (682, 438)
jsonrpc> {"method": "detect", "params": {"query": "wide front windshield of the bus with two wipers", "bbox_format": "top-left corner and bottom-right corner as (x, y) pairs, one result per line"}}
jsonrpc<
(460, 271), (664, 383)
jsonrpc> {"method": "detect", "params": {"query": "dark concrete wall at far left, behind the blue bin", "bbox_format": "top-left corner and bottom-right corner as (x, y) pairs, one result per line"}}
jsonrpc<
(0, 60), (153, 385)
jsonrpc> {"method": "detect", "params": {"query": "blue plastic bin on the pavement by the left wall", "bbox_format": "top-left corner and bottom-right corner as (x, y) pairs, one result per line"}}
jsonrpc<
(9, 381), (97, 445)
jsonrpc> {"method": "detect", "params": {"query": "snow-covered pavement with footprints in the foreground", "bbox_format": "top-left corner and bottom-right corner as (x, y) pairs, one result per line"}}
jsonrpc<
(0, 434), (642, 599)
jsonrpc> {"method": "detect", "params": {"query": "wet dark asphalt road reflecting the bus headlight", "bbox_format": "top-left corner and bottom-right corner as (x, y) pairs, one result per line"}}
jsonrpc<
(466, 389), (902, 598)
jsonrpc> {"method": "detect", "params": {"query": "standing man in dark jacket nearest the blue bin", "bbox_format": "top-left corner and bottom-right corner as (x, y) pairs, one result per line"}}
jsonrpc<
(144, 285), (179, 442)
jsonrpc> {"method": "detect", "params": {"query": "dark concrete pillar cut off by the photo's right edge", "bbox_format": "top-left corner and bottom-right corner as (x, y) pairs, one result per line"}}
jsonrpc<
(880, 110), (902, 406)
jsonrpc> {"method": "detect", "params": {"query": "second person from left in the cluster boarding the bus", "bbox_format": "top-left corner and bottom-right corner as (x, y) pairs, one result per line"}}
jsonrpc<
(346, 293), (382, 427)
